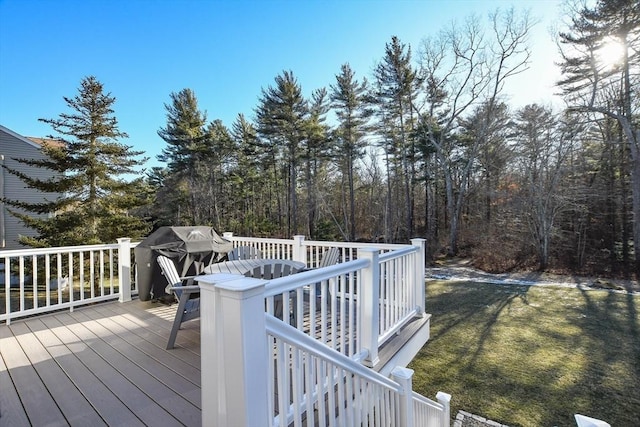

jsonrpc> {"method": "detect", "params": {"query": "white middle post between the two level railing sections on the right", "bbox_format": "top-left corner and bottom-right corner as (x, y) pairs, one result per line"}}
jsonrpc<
(358, 248), (380, 367)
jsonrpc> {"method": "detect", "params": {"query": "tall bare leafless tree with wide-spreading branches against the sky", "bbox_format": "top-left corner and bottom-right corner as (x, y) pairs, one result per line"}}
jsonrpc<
(415, 9), (533, 255)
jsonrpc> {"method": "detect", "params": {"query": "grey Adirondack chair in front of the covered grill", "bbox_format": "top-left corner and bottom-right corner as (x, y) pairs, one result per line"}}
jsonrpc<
(157, 255), (200, 350)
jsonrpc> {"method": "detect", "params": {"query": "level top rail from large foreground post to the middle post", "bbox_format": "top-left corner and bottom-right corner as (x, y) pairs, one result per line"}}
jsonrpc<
(265, 259), (370, 297)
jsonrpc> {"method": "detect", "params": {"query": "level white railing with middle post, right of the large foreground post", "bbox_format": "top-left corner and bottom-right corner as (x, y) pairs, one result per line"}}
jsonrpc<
(265, 239), (424, 366)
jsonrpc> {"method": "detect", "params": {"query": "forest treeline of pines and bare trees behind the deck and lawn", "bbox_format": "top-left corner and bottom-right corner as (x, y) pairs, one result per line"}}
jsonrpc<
(6, 0), (640, 275)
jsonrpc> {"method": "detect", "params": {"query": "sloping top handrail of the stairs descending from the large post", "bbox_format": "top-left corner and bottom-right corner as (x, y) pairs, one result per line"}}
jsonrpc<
(265, 313), (402, 393)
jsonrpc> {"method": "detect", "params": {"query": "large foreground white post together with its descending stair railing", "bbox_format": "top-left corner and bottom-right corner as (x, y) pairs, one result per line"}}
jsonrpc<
(198, 274), (450, 427)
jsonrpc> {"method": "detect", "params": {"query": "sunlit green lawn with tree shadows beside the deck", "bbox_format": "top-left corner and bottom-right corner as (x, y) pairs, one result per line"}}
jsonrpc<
(409, 281), (640, 427)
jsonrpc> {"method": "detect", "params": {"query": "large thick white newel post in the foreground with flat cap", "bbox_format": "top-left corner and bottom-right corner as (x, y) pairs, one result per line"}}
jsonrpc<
(196, 274), (270, 427)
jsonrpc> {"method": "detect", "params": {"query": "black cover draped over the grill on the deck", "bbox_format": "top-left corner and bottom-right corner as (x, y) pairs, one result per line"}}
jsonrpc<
(134, 226), (233, 301)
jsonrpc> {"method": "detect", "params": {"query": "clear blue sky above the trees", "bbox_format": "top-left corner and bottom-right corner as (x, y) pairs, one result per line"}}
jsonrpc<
(0, 0), (560, 172)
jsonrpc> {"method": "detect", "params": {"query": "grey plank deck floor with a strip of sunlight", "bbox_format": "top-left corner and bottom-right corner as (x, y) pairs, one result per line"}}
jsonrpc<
(0, 300), (201, 427)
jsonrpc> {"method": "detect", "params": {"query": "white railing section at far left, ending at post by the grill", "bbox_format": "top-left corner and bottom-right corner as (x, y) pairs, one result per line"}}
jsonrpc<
(0, 238), (136, 324)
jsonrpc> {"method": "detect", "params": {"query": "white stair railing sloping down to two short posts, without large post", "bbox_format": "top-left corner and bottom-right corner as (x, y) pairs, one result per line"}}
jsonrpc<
(264, 313), (451, 427)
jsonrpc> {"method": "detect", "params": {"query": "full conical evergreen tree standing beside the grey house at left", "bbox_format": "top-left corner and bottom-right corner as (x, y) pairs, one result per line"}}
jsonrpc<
(4, 76), (148, 247)
